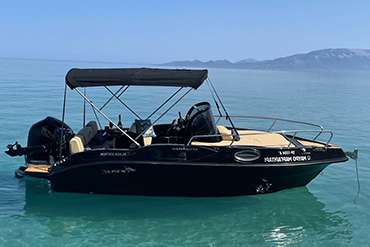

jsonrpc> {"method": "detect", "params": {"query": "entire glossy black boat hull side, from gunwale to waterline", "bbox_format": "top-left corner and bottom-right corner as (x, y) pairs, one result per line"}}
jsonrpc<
(50, 146), (347, 197)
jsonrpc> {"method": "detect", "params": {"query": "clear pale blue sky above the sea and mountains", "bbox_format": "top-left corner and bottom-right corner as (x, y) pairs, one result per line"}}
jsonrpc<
(0, 0), (370, 64)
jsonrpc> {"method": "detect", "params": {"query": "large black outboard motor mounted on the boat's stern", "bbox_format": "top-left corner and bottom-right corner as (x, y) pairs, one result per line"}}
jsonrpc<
(6, 117), (74, 163)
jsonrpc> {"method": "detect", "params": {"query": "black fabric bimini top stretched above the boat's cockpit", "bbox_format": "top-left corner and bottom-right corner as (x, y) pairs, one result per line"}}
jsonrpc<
(66, 68), (208, 89)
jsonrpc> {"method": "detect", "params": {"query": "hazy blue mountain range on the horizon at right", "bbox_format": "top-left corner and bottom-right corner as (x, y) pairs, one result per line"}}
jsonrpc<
(162, 49), (370, 70)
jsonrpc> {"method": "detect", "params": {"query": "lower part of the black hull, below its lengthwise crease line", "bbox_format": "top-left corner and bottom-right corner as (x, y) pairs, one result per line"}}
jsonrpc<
(50, 161), (327, 197)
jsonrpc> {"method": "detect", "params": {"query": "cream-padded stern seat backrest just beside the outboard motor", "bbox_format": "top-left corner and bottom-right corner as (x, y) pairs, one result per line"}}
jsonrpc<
(69, 121), (98, 154)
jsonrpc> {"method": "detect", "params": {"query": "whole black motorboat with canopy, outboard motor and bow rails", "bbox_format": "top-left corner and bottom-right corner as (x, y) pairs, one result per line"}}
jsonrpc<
(6, 68), (348, 197)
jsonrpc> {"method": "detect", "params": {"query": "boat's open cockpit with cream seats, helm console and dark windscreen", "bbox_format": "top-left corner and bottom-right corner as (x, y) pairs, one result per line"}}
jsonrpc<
(69, 102), (221, 153)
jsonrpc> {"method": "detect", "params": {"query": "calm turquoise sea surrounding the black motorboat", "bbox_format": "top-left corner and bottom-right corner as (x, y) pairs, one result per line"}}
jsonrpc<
(0, 59), (370, 247)
